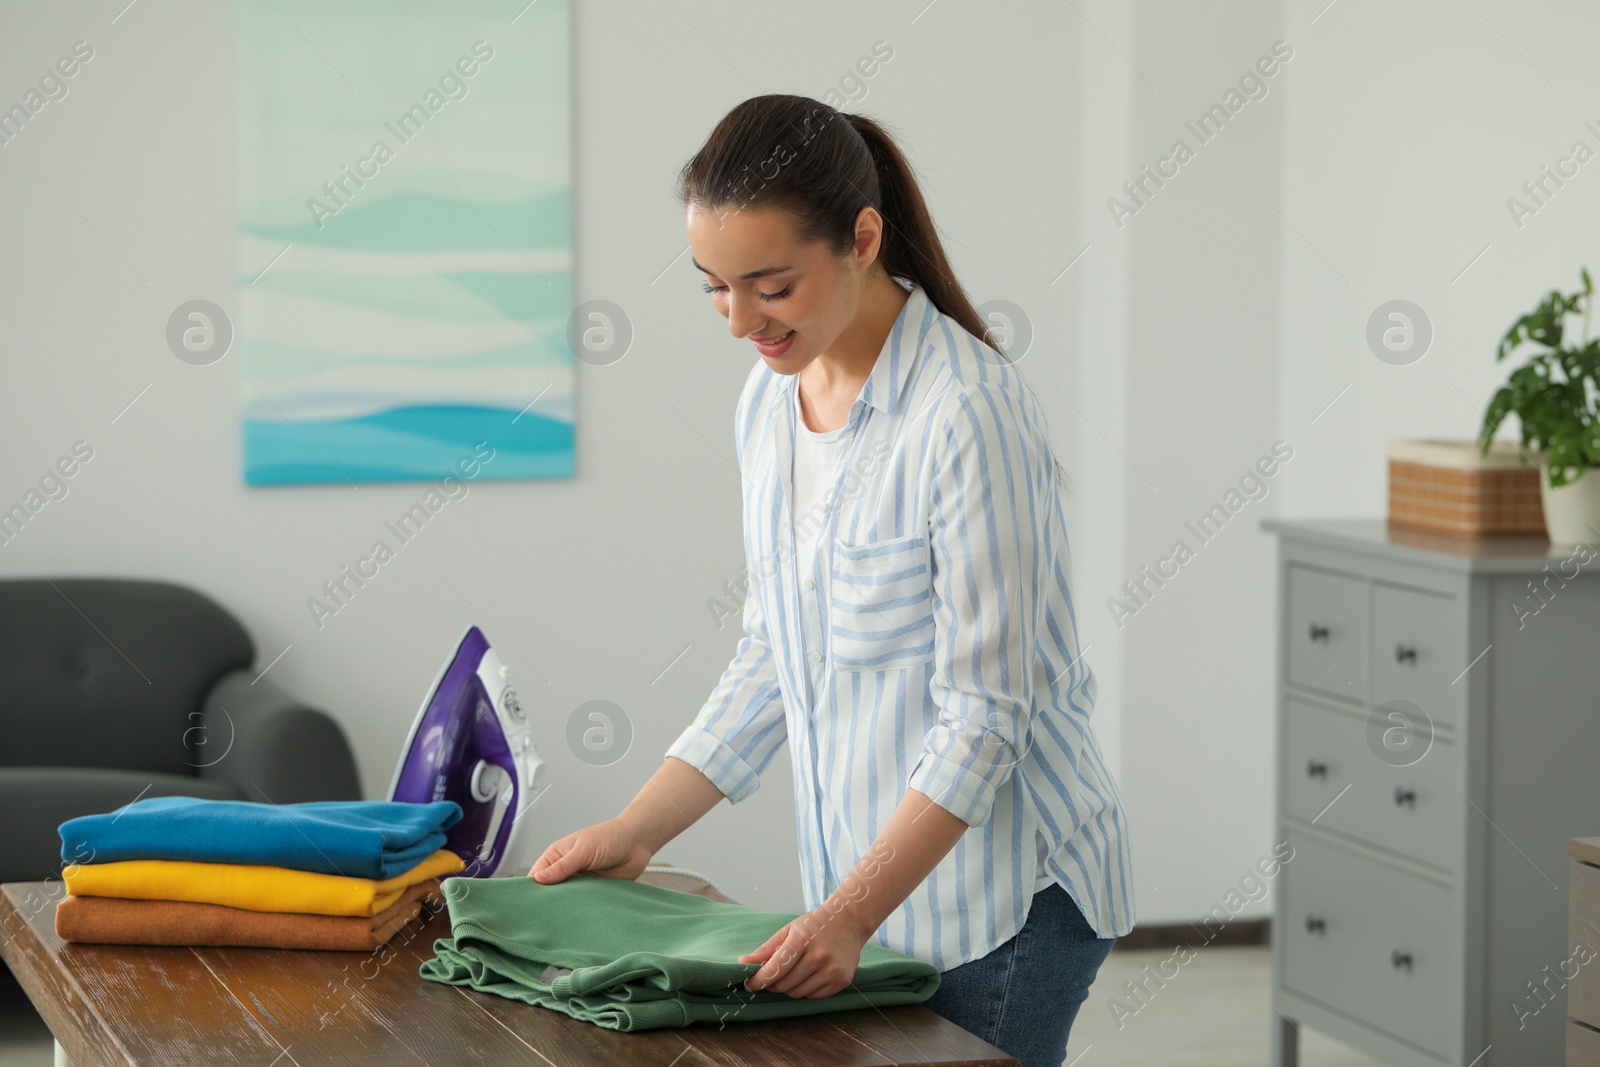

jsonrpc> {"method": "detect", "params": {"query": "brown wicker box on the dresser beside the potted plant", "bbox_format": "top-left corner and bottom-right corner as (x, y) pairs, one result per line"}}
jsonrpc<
(1389, 438), (1544, 537)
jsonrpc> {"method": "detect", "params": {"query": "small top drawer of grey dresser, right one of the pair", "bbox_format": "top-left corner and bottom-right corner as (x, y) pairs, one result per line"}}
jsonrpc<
(1373, 582), (1467, 726)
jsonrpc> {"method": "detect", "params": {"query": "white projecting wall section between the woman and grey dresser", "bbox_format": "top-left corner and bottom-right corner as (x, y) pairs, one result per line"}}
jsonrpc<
(1074, 0), (1296, 923)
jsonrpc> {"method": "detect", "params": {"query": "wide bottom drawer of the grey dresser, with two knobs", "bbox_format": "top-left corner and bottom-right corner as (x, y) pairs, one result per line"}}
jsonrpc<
(1274, 831), (1462, 1056)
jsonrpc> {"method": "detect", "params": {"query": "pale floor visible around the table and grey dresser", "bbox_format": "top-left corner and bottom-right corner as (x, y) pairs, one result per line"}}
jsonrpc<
(0, 947), (1382, 1067)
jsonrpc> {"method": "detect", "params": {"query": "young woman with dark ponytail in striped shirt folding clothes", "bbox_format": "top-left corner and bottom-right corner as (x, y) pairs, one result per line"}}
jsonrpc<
(528, 94), (1133, 1067)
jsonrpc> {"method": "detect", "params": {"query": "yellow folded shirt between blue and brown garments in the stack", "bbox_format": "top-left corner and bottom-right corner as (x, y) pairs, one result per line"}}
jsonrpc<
(61, 848), (466, 917)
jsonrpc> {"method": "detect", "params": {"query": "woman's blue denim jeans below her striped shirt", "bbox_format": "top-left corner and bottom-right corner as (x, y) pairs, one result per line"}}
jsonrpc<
(922, 881), (1117, 1067)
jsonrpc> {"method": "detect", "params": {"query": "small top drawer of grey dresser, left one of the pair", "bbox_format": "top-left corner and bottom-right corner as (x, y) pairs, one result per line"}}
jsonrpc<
(1286, 565), (1366, 701)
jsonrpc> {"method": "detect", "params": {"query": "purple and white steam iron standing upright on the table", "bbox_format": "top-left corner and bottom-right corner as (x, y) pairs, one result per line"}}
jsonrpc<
(389, 625), (544, 878)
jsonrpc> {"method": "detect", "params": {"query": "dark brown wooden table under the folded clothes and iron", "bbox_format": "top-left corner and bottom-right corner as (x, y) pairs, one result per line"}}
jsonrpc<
(0, 877), (1016, 1067)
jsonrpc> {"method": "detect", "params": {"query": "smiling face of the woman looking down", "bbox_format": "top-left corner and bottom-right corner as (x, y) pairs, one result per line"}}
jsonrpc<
(688, 205), (880, 374)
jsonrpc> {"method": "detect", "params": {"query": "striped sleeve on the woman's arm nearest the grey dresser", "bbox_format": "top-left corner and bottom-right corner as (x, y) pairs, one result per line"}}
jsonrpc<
(907, 384), (1054, 825)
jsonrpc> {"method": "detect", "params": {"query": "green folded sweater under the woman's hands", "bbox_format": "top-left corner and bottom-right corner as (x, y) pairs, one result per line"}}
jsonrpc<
(418, 875), (939, 1030)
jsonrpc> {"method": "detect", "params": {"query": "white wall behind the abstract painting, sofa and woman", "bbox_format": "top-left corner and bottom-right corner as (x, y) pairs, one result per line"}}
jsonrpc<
(0, 0), (1093, 910)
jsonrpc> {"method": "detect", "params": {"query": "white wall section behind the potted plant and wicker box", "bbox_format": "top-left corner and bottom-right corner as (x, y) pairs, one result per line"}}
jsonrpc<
(1280, 0), (1600, 515)
